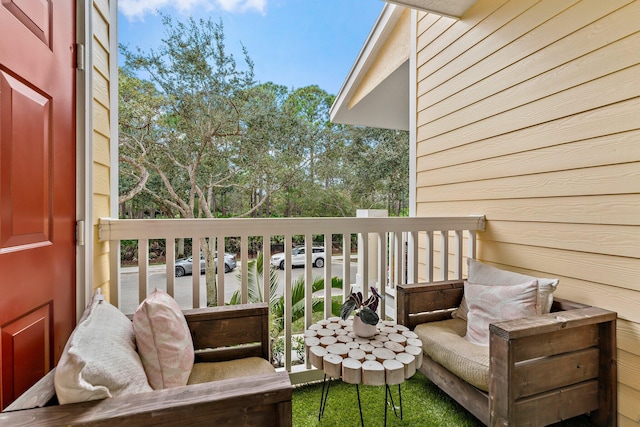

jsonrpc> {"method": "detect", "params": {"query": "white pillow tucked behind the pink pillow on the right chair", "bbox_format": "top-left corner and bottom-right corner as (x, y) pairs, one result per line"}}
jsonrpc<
(452, 258), (559, 320)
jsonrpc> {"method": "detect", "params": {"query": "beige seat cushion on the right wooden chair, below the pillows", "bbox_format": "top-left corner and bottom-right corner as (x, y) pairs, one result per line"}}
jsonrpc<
(415, 319), (489, 391)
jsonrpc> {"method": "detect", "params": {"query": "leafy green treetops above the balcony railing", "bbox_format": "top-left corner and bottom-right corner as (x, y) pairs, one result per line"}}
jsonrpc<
(119, 17), (409, 222)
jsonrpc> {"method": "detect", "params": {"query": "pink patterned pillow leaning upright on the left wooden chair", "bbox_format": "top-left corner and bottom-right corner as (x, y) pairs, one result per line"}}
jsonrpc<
(133, 289), (194, 390)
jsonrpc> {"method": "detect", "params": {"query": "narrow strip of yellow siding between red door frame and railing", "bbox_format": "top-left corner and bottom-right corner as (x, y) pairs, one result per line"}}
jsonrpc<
(90, 0), (117, 297)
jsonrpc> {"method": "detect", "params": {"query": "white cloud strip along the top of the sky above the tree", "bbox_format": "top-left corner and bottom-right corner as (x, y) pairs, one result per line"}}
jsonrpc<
(118, 0), (267, 21)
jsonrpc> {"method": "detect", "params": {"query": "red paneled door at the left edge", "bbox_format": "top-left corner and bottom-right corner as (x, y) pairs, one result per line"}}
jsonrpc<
(0, 0), (76, 408)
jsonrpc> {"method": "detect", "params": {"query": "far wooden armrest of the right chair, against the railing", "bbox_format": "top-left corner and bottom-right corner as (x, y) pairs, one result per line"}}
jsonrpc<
(396, 280), (464, 329)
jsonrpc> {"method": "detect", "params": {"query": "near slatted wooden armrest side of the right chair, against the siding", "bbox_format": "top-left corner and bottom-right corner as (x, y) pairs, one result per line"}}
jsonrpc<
(489, 307), (617, 425)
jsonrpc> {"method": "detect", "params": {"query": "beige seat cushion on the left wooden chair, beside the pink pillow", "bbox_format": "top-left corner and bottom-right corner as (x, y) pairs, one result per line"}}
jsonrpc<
(187, 357), (276, 384)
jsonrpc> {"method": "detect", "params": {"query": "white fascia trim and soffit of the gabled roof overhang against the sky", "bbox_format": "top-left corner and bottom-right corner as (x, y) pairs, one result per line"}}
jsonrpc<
(330, 4), (409, 130)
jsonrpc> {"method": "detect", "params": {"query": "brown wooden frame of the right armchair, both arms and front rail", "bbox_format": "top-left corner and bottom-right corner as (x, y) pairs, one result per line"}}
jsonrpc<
(397, 281), (617, 427)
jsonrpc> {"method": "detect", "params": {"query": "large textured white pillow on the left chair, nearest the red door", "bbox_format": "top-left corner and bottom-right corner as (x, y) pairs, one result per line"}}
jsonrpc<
(54, 294), (152, 404)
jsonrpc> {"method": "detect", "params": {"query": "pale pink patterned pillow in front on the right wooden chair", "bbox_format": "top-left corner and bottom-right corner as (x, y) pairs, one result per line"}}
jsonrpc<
(464, 280), (540, 346)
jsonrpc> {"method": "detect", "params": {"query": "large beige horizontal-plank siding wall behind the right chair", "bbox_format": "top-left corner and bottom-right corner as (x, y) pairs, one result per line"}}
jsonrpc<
(416, 0), (640, 426)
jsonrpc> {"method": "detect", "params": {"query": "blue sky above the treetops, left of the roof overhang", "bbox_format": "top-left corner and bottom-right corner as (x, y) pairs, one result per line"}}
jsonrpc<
(118, 0), (384, 95)
